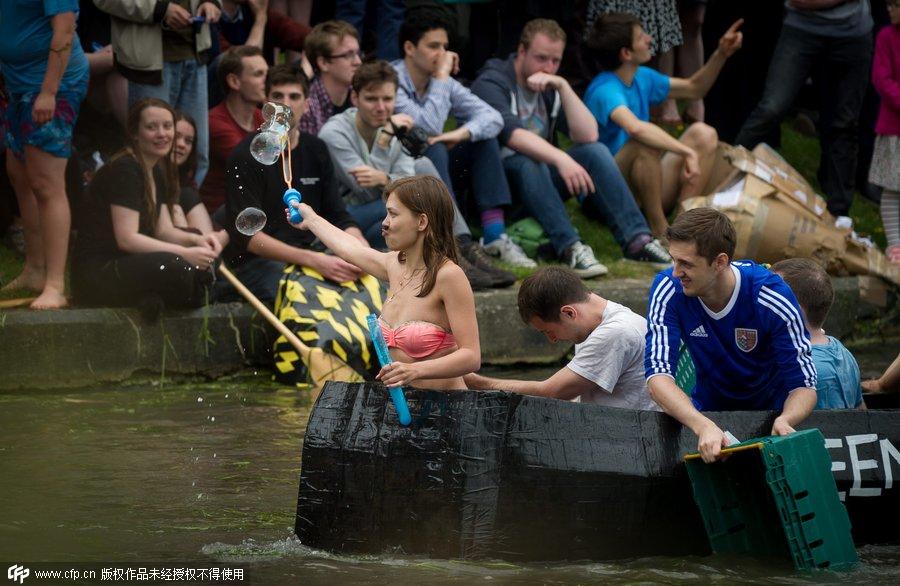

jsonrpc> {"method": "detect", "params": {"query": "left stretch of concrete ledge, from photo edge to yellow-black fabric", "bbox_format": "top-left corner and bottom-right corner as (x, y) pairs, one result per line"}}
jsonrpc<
(0, 303), (274, 390)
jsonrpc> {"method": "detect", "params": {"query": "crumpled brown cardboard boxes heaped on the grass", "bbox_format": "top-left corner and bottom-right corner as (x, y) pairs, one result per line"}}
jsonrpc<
(679, 143), (900, 285)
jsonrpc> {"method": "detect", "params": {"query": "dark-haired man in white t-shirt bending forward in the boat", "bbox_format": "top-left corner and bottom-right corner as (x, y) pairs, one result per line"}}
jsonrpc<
(465, 267), (659, 411)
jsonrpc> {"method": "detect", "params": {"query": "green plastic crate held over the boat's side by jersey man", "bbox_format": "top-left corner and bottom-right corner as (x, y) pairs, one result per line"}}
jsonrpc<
(685, 429), (859, 570)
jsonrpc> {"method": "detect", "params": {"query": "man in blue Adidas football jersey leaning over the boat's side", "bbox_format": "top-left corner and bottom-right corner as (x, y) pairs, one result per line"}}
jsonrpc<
(644, 208), (816, 462)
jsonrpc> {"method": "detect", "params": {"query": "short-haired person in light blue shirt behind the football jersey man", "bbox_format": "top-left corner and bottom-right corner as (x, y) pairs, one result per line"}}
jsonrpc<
(772, 258), (866, 409)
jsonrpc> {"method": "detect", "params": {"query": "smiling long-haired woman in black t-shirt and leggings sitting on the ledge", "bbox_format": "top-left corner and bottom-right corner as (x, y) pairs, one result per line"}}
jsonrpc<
(72, 98), (222, 317)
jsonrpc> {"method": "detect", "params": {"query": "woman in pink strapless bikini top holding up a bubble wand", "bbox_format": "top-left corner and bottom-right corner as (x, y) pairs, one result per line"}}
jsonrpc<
(294, 176), (481, 390)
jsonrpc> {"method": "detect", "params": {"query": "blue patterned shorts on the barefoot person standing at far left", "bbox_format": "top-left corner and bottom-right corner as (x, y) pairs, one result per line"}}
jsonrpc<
(0, 86), (87, 160)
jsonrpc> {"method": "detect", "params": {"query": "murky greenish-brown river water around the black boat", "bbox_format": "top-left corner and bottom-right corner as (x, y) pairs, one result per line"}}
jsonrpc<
(0, 344), (900, 584)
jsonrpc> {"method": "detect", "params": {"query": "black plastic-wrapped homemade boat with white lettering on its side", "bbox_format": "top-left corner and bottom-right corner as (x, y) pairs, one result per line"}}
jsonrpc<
(295, 383), (900, 561)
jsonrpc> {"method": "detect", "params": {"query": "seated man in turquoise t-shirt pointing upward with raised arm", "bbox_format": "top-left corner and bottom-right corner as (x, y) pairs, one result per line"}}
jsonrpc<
(584, 13), (743, 238)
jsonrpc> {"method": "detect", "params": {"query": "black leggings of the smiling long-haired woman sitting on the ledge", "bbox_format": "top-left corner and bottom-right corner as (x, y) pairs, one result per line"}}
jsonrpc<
(72, 252), (212, 307)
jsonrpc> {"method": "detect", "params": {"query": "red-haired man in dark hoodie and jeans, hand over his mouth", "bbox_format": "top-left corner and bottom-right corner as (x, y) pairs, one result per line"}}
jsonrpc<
(472, 19), (672, 278)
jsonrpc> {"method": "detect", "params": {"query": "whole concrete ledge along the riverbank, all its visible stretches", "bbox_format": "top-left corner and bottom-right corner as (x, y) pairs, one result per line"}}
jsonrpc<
(0, 277), (877, 390)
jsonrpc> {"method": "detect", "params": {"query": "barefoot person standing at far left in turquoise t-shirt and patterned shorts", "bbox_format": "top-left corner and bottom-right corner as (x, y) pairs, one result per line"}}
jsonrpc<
(0, 0), (90, 309)
